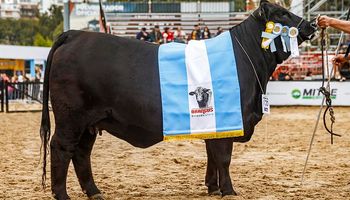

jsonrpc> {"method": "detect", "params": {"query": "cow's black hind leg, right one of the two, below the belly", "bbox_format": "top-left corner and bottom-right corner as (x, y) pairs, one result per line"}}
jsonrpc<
(72, 130), (103, 200)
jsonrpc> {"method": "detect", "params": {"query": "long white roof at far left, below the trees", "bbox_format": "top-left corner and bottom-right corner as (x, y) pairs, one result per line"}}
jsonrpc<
(0, 45), (51, 60)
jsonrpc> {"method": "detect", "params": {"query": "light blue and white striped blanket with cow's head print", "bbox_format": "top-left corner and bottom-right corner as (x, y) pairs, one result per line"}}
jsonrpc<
(158, 32), (243, 140)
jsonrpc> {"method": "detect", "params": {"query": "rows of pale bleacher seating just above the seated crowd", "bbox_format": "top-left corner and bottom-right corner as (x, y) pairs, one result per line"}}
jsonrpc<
(106, 12), (248, 37)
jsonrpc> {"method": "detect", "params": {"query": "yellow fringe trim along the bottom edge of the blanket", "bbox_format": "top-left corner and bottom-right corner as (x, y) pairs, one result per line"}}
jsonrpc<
(163, 130), (244, 141)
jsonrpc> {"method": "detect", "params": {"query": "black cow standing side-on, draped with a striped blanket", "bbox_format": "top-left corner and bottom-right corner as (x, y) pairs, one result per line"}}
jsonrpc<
(40, 1), (315, 199)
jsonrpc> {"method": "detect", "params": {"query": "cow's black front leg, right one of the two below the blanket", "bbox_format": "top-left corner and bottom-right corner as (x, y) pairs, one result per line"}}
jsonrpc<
(205, 138), (237, 196)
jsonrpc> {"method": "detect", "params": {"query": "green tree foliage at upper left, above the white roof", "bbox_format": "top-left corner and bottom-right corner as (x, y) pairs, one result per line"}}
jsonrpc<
(0, 5), (63, 46)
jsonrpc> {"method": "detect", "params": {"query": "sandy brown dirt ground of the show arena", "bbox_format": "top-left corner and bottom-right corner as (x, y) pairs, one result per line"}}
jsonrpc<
(0, 107), (350, 200)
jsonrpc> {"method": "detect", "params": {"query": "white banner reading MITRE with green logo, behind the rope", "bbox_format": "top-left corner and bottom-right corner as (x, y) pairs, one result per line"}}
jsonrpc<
(267, 81), (350, 106)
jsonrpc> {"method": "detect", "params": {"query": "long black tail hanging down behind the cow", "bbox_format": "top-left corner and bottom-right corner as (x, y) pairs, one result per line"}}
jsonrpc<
(40, 33), (68, 189)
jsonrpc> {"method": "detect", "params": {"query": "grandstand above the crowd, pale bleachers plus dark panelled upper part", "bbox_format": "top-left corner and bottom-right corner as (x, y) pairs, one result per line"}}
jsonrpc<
(101, 0), (248, 37)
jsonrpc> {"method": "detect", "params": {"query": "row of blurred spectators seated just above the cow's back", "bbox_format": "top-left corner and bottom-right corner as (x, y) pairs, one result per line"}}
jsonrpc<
(136, 25), (223, 44)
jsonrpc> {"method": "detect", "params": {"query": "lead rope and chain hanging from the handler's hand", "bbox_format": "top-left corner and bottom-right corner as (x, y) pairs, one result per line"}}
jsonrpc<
(301, 28), (341, 184)
